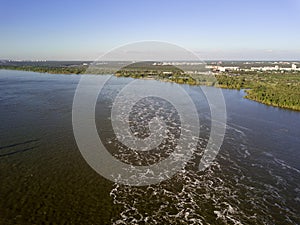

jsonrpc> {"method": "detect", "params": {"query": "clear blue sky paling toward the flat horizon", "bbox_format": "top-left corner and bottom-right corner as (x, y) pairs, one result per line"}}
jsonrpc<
(0, 0), (300, 60)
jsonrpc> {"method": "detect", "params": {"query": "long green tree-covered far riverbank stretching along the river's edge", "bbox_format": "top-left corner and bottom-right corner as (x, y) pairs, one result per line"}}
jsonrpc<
(0, 66), (300, 111)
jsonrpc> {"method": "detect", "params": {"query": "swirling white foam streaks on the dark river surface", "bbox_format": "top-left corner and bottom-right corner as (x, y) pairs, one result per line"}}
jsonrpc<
(106, 96), (300, 225)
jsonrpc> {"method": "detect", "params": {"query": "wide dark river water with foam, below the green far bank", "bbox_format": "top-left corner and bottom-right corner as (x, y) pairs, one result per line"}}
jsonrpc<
(0, 70), (300, 224)
